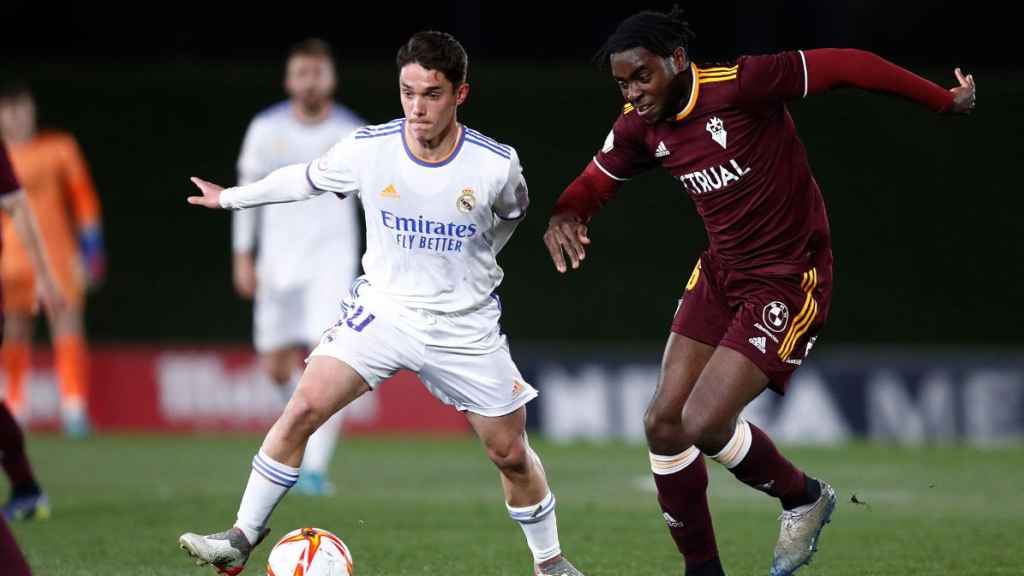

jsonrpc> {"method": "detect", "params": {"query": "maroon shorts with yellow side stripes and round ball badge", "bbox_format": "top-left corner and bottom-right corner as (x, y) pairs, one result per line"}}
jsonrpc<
(672, 252), (831, 394)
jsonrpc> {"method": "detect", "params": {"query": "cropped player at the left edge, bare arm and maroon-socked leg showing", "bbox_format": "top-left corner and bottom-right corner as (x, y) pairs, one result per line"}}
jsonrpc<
(0, 140), (63, 576)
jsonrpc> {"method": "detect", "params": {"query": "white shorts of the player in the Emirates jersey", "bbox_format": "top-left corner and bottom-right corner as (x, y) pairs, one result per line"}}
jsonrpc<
(309, 281), (537, 416)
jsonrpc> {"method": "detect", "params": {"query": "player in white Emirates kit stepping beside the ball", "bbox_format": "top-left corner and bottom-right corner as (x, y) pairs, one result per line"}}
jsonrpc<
(179, 32), (581, 576)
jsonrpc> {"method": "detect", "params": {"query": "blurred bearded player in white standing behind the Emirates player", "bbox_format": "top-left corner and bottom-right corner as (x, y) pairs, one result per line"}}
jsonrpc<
(231, 38), (364, 494)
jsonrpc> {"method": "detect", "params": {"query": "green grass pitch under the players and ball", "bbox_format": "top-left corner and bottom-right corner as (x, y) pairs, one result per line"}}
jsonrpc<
(9, 436), (1024, 576)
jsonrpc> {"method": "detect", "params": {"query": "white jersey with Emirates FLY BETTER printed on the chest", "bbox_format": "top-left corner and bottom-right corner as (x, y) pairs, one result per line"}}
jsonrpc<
(306, 119), (529, 314)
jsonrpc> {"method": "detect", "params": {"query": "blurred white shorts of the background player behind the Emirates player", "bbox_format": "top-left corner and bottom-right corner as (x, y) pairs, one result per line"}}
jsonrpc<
(253, 274), (352, 354)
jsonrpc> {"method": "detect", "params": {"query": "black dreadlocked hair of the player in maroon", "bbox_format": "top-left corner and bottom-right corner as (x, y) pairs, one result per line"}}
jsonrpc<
(594, 5), (694, 66)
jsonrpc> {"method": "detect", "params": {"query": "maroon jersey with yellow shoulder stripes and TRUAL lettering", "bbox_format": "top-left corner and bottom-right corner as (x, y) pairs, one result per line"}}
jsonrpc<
(594, 52), (831, 274)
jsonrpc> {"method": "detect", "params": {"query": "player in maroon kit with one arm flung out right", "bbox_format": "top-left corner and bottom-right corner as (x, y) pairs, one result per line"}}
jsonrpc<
(544, 9), (975, 576)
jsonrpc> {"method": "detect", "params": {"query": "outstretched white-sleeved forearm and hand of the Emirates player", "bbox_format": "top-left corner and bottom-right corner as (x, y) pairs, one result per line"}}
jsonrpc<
(187, 164), (324, 210)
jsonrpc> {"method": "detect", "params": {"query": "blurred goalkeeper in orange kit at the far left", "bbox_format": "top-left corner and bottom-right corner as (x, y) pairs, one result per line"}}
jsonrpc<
(0, 82), (105, 438)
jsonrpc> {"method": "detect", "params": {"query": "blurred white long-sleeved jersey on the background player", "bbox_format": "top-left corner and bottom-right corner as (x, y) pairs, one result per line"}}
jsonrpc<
(232, 100), (364, 289)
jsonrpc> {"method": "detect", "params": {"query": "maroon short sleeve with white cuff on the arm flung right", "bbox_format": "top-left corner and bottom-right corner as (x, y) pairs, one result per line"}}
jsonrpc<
(737, 50), (807, 105)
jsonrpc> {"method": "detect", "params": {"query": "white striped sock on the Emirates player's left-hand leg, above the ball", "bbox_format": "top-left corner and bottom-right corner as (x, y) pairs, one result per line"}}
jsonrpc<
(234, 450), (299, 543)
